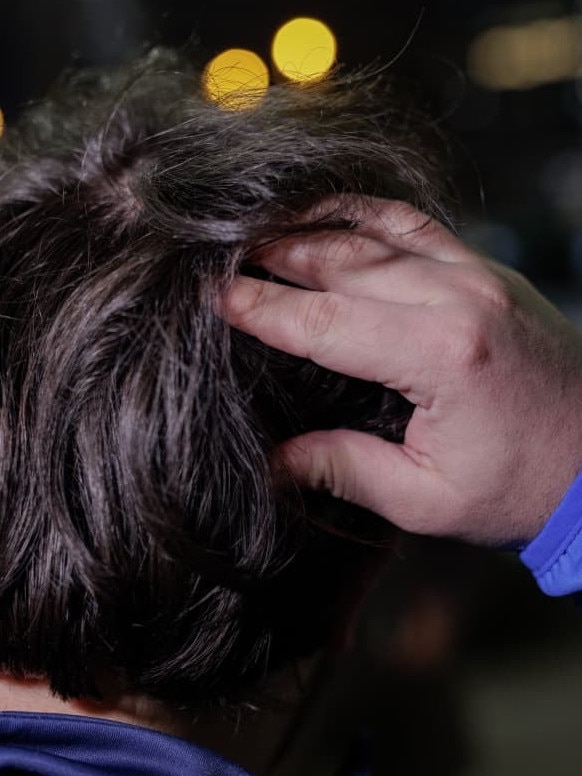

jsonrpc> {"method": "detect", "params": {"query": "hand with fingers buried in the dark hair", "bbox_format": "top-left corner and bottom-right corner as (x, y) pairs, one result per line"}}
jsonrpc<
(226, 197), (582, 544)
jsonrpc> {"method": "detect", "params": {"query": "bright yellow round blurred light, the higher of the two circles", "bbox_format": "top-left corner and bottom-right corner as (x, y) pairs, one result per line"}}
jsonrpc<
(271, 17), (337, 82)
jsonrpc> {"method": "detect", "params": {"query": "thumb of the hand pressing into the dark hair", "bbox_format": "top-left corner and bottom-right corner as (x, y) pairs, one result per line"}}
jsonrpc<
(277, 429), (454, 534)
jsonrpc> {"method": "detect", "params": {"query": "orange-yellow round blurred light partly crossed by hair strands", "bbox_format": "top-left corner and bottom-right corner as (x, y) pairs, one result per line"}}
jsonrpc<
(202, 49), (269, 110)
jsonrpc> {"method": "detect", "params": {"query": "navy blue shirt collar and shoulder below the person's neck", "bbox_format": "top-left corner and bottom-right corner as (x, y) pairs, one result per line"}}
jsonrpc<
(0, 711), (249, 776)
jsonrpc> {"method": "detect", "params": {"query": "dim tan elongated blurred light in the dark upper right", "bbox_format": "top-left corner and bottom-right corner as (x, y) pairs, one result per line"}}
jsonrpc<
(467, 16), (582, 90)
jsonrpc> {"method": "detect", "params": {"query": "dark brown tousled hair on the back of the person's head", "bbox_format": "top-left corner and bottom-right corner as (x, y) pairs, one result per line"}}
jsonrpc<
(0, 54), (456, 705)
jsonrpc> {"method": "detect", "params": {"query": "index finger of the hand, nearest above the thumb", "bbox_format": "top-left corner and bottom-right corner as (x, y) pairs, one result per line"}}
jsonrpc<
(224, 277), (446, 406)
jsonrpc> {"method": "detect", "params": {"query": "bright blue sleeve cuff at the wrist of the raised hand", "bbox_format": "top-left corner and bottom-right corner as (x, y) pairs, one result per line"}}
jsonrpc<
(519, 473), (582, 596)
